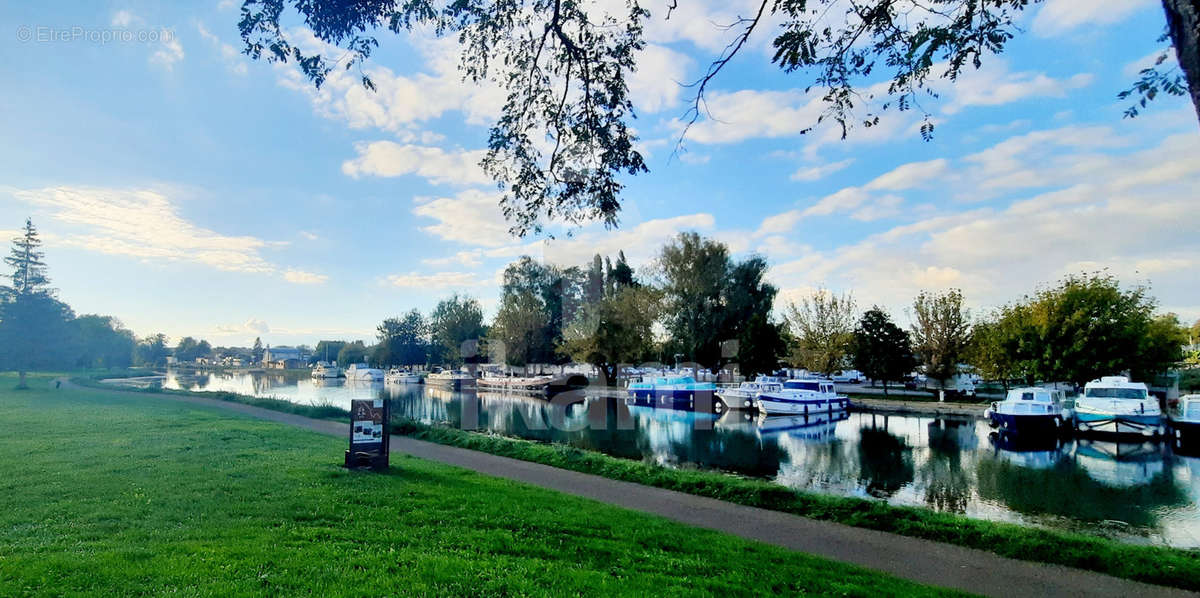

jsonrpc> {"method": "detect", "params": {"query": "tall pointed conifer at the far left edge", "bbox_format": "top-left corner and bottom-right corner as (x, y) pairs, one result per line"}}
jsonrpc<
(0, 220), (74, 388)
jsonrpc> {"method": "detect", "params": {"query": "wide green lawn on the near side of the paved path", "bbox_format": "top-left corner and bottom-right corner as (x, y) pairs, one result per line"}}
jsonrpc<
(0, 377), (942, 596)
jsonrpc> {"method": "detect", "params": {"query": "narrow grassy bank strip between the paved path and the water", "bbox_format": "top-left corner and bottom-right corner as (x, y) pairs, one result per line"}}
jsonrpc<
(72, 373), (1200, 591)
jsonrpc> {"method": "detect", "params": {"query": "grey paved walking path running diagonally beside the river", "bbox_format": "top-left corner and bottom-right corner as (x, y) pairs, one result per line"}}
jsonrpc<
(66, 383), (1194, 598)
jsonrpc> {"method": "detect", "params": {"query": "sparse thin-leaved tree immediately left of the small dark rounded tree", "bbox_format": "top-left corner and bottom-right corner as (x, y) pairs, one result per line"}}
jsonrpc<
(786, 288), (856, 376)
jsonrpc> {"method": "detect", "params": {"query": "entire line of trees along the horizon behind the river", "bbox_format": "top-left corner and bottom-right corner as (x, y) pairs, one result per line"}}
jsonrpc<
(0, 220), (1200, 387)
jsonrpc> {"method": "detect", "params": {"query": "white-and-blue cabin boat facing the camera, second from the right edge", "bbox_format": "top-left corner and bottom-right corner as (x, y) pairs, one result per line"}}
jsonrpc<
(1075, 376), (1166, 436)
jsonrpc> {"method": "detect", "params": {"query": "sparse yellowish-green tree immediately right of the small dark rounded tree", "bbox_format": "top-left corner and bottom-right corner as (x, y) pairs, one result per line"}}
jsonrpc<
(912, 288), (971, 382)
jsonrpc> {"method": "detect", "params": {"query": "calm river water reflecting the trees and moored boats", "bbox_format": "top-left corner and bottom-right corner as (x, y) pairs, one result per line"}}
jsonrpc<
(136, 373), (1200, 548)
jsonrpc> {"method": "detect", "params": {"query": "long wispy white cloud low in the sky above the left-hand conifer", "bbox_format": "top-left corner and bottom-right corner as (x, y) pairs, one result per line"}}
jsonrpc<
(12, 186), (318, 282)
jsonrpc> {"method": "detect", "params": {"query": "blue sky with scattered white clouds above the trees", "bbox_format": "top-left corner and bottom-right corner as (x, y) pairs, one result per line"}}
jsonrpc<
(0, 0), (1200, 346)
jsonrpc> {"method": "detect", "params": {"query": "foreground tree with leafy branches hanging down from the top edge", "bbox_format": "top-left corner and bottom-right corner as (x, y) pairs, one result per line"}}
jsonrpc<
(238, 0), (1200, 234)
